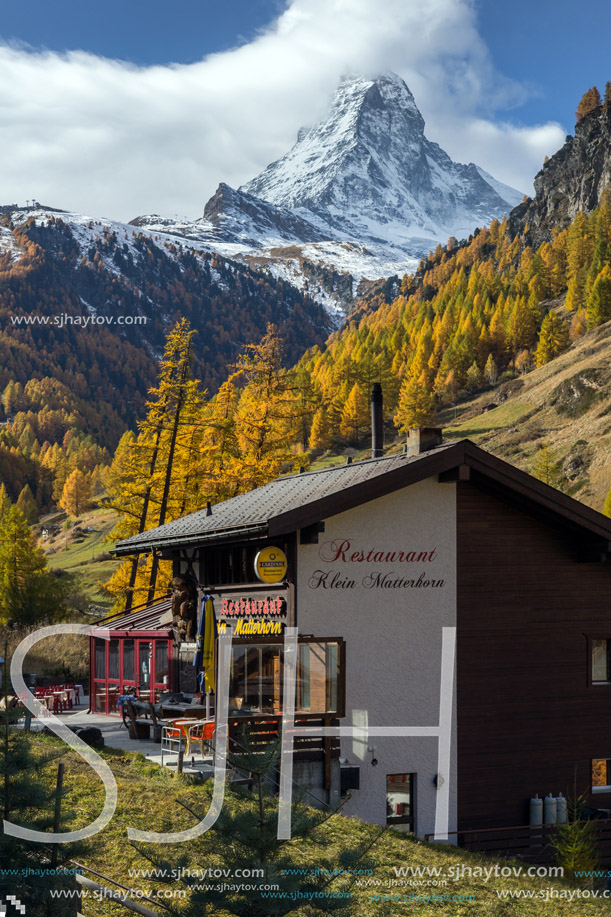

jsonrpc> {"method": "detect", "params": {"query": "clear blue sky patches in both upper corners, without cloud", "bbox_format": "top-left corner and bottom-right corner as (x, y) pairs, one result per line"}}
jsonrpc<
(0, 0), (611, 129)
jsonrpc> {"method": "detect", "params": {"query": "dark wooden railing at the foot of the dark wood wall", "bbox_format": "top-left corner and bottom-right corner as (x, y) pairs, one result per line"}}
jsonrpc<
(425, 818), (611, 867)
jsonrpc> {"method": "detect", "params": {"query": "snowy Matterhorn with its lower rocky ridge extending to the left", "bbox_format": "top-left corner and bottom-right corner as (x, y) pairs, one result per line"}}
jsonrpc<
(138, 73), (522, 309)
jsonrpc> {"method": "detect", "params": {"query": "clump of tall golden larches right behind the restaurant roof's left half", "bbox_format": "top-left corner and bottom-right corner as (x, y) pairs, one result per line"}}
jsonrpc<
(106, 320), (312, 611)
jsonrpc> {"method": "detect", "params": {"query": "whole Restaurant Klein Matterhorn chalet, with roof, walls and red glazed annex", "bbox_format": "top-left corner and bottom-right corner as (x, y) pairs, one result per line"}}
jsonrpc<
(101, 418), (611, 835)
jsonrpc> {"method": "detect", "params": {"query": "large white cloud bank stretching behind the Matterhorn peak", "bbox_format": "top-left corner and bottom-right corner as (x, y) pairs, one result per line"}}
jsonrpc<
(0, 0), (564, 219)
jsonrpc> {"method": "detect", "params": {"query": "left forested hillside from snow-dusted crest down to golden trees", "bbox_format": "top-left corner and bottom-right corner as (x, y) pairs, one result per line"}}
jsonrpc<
(0, 208), (330, 514)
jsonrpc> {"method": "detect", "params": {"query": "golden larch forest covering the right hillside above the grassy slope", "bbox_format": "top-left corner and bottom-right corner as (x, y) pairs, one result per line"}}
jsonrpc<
(299, 194), (611, 448)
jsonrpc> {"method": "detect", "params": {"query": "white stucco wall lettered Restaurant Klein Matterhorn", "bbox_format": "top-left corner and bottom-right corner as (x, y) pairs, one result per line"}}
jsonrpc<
(297, 478), (456, 835)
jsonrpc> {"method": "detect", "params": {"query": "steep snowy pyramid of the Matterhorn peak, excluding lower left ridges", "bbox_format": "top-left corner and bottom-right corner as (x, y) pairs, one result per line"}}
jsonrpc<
(240, 73), (521, 250)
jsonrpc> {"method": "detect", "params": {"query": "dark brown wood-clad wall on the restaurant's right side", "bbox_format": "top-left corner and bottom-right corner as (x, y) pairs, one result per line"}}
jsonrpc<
(457, 481), (611, 830)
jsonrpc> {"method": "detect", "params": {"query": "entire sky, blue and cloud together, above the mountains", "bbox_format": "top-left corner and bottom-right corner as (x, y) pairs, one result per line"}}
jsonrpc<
(0, 0), (611, 219)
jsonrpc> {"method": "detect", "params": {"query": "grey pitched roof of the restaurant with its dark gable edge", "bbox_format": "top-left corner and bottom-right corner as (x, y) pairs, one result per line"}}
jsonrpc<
(114, 439), (611, 555)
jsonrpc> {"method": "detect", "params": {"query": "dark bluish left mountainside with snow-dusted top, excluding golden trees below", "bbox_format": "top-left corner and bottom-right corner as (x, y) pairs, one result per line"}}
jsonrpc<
(0, 208), (331, 445)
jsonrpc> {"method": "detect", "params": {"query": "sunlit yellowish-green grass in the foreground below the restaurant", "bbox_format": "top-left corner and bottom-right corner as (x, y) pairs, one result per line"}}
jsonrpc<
(10, 736), (609, 917)
